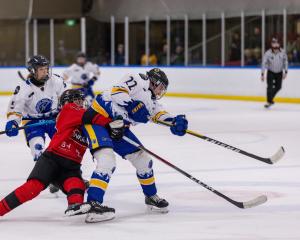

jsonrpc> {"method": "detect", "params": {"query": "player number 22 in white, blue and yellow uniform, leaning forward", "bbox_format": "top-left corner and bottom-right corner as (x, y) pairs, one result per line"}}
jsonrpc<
(78, 68), (188, 222)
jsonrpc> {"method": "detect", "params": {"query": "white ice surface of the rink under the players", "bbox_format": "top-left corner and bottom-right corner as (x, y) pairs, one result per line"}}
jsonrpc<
(0, 97), (300, 240)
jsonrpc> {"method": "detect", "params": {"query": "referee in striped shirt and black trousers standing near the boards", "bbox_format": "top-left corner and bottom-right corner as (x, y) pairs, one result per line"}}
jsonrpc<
(261, 38), (288, 108)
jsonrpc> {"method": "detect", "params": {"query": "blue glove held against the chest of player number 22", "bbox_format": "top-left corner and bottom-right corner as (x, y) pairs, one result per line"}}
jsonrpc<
(125, 101), (150, 123)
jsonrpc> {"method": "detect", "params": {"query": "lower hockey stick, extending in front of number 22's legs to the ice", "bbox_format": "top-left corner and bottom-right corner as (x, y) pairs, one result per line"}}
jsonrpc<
(123, 136), (268, 208)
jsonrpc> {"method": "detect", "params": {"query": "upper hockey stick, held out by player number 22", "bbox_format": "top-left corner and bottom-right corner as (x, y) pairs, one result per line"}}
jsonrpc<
(153, 120), (285, 164)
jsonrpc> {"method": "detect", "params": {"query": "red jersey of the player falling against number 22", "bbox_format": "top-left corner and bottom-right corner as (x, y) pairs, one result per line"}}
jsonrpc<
(46, 103), (111, 163)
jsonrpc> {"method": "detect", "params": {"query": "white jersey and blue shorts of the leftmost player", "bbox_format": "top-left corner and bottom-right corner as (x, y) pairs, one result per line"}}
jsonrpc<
(7, 75), (66, 141)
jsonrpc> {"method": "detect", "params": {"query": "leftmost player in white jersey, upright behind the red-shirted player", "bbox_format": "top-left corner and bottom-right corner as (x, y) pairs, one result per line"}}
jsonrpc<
(5, 55), (66, 161)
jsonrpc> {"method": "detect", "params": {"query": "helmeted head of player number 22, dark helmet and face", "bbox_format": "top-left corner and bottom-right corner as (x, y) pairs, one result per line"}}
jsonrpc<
(147, 68), (169, 99)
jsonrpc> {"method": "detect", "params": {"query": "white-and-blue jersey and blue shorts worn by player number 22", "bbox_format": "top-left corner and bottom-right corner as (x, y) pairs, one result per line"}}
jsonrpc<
(84, 74), (172, 158)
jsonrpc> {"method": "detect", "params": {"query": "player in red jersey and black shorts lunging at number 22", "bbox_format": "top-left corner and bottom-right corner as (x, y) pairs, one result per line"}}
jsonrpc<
(0, 89), (124, 216)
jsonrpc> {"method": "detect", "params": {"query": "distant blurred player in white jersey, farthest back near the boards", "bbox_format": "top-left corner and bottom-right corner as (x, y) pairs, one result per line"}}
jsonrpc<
(63, 52), (100, 104)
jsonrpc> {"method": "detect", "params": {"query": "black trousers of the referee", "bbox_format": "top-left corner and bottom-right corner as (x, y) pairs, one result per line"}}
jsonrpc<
(267, 71), (282, 103)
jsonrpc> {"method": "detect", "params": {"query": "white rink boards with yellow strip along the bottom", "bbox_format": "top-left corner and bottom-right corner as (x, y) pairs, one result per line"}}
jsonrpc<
(0, 66), (300, 103)
